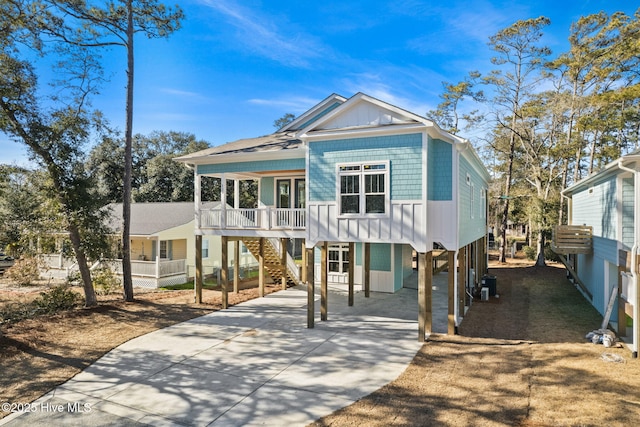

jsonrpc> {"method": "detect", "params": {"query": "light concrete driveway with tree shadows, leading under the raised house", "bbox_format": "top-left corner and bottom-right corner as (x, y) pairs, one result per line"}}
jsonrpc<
(0, 280), (446, 426)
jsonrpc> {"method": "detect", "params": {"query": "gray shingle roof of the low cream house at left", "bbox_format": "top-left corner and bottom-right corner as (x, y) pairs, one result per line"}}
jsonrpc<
(107, 202), (219, 236)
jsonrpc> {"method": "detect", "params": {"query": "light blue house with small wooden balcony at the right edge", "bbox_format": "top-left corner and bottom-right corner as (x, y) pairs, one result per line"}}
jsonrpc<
(553, 151), (640, 357)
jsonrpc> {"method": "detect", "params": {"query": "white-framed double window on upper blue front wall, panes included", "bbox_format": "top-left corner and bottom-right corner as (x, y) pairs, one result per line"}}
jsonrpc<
(338, 163), (389, 214)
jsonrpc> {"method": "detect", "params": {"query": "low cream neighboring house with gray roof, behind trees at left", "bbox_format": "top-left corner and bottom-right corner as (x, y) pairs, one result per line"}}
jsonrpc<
(38, 202), (255, 288)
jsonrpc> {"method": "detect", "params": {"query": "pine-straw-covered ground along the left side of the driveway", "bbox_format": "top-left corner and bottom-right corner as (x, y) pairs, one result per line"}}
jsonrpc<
(0, 282), (280, 418)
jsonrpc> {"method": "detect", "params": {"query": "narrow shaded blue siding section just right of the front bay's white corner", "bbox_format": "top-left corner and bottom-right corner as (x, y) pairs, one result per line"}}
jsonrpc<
(427, 138), (453, 200)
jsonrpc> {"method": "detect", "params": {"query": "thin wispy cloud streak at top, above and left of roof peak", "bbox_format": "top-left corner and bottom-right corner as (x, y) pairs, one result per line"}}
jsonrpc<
(201, 0), (328, 68)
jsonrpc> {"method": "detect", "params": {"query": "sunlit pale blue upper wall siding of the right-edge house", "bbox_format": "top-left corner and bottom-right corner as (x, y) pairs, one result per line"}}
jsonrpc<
(572, 177), (617, 240)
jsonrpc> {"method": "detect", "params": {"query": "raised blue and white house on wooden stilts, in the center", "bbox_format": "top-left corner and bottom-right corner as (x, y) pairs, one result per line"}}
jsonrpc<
(176, 93), (489, 339)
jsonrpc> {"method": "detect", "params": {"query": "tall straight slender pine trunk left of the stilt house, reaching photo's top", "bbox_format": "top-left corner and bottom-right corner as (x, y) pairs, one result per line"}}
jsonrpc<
(122, 0), (133, 301)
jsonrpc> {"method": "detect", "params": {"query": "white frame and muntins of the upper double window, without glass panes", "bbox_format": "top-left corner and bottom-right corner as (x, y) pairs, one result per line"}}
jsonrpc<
(336, 160), (391, 218)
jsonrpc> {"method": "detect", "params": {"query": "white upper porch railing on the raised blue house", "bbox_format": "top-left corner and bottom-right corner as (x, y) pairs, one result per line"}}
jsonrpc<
(200, 207), (306, 230)
